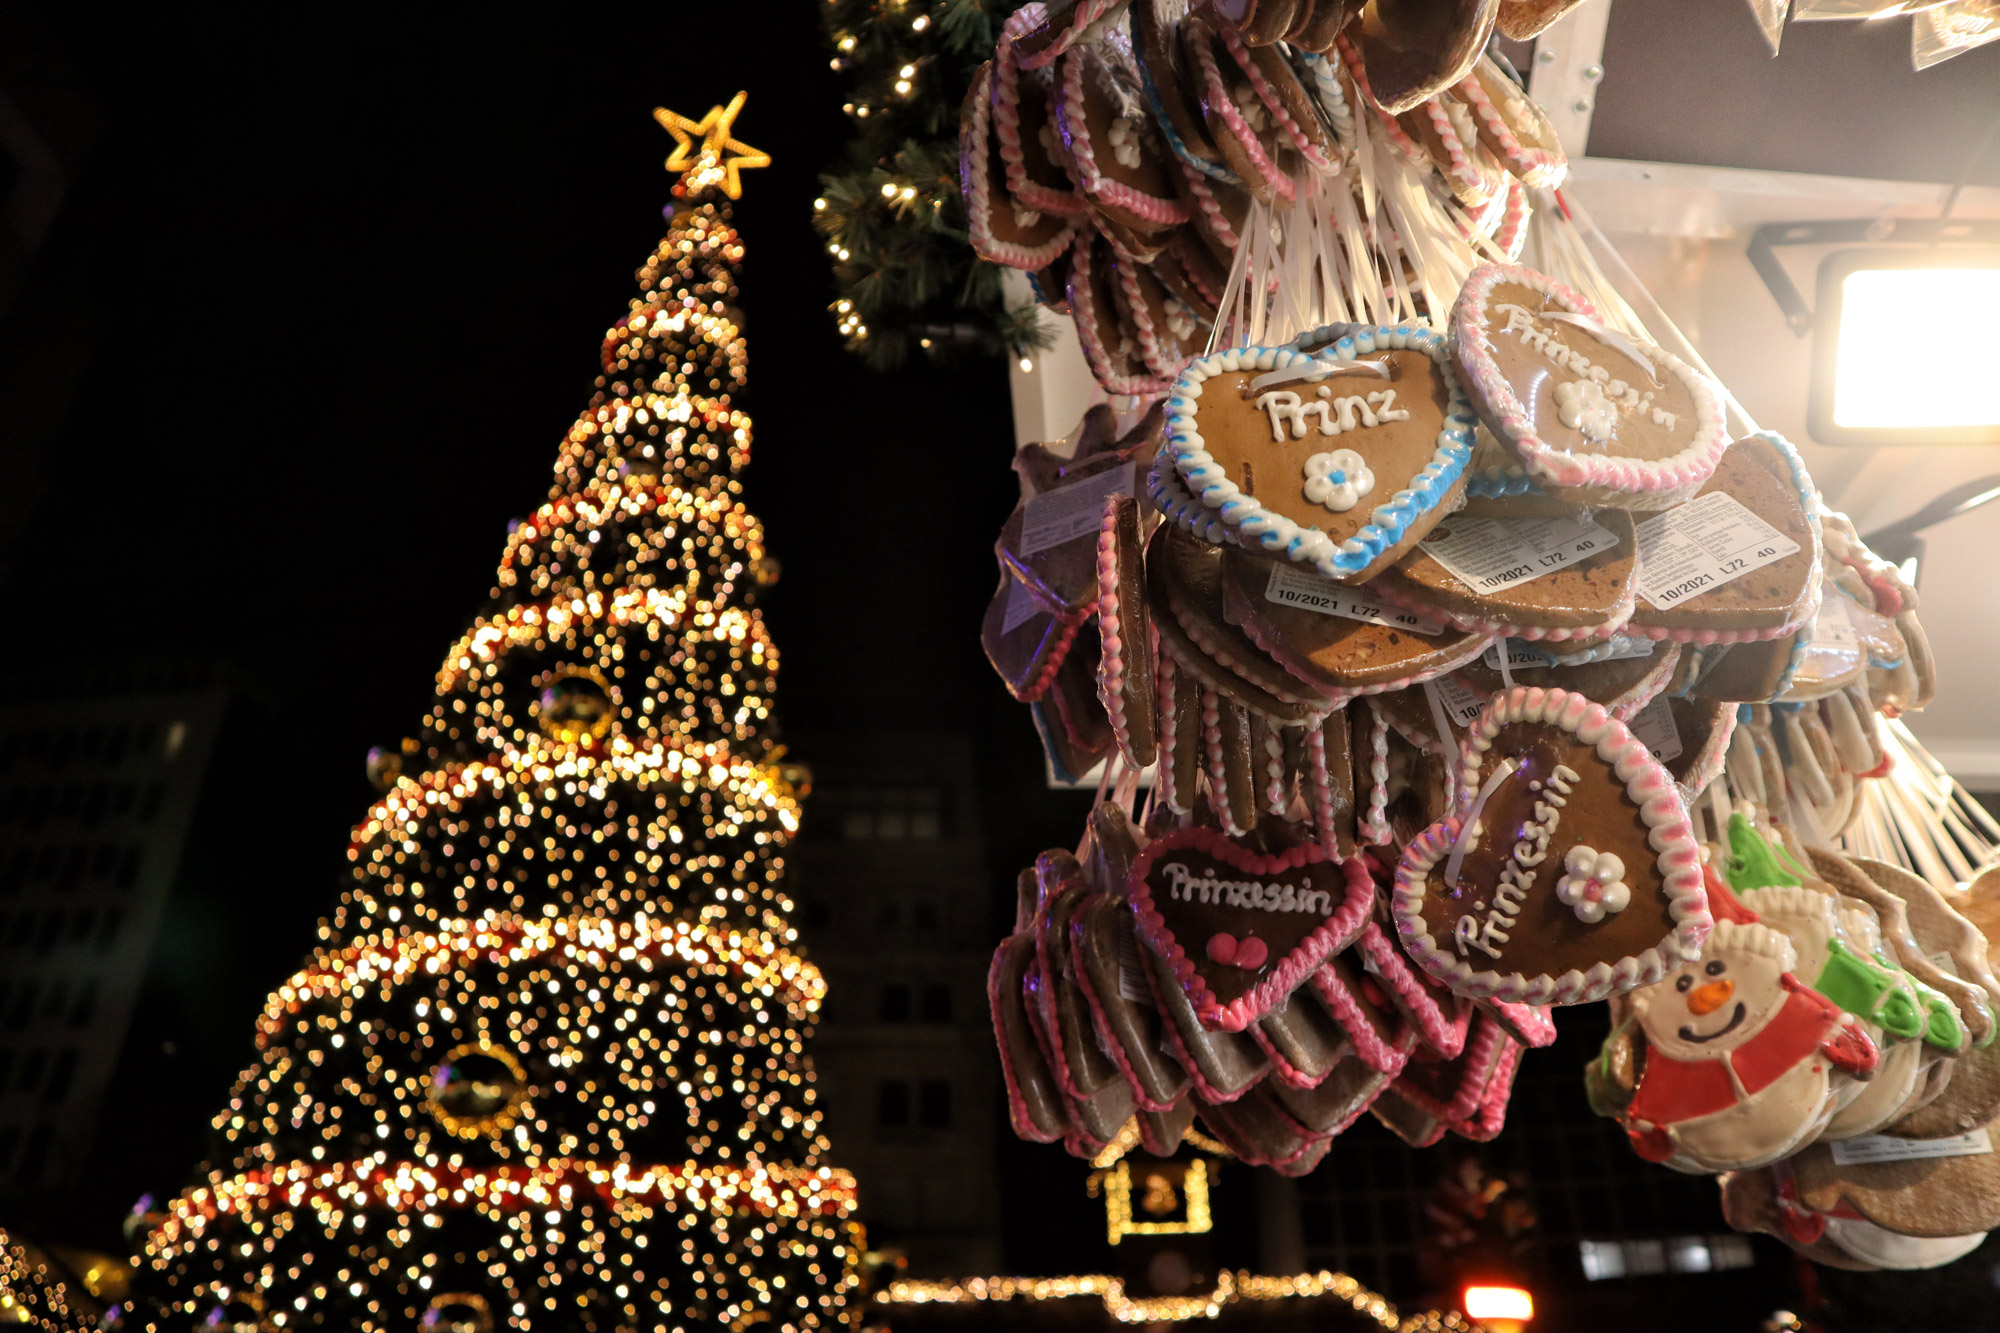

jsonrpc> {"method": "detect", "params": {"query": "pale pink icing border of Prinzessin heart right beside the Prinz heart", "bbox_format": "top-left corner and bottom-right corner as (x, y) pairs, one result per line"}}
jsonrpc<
(1448, 264), (1728, 494)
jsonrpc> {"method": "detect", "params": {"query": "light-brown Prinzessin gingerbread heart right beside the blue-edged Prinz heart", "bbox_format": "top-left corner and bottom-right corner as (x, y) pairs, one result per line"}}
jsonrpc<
(1450, 264), (1728, 508)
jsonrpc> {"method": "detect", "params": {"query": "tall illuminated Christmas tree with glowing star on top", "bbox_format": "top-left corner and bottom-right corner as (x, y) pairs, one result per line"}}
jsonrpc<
(130, 94), (856, 1333)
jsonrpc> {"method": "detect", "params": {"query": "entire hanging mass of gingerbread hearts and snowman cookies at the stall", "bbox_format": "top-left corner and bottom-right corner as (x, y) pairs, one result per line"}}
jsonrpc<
(966, 0), (2000, 1255)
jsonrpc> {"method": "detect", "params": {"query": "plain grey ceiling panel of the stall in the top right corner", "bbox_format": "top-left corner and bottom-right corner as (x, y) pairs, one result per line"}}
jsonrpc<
(1590, 0), (2000, 184)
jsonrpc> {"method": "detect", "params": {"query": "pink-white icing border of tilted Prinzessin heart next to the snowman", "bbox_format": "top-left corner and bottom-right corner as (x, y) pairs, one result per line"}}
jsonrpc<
(1390, 687), (1712, 1005)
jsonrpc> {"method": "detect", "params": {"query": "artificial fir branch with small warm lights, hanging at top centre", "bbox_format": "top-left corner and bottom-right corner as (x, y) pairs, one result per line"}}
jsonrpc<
(816, 0), (1048, 370)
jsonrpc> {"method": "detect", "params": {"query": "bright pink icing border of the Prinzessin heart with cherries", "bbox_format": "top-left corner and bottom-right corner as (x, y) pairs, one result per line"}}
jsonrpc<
(1130, 829), (1374, 1033)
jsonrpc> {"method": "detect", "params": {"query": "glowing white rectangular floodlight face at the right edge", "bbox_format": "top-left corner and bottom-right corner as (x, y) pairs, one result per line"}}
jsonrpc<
(1834, 268), (2000, 428)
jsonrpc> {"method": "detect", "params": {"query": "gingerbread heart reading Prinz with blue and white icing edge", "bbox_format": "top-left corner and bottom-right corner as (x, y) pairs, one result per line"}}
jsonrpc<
(1166, 326), (1472, 582)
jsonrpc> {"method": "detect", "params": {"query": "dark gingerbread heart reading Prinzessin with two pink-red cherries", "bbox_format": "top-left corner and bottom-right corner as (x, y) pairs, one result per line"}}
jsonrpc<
(1132, 827), (1374, 1033)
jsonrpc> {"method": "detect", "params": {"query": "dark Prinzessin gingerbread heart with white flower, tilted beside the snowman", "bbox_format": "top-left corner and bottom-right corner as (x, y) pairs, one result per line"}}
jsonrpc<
(1392, 689), (1710, 1005)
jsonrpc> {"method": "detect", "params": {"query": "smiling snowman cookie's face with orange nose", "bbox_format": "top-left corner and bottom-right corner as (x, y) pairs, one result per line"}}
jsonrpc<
(1634, 921), (1794, 1061)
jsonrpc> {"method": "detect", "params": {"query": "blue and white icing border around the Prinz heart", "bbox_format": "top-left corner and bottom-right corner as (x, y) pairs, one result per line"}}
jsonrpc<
(1166, 324), (1474, 578)
